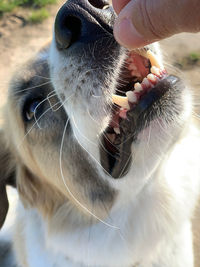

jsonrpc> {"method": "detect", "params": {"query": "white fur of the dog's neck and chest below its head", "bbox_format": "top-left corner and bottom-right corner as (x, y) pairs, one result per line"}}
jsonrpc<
(14, 121), (200, 267)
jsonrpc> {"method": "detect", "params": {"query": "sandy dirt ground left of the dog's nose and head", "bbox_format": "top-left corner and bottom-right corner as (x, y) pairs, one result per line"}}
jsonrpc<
(0, 1), (65, 108)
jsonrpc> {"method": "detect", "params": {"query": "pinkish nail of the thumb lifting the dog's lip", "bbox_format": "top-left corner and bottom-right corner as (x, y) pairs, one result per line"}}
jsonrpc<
(114, 18), (146, 50)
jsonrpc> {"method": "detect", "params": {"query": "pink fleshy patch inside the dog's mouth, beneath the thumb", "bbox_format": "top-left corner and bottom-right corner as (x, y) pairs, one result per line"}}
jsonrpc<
(127, 53), (149, 79)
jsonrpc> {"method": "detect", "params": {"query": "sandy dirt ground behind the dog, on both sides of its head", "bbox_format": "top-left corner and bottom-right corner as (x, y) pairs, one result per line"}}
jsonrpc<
(0, 1), (200, 111)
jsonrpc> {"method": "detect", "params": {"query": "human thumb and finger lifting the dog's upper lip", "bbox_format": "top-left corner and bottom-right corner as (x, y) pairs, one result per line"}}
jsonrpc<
(112, 0), (200, 50)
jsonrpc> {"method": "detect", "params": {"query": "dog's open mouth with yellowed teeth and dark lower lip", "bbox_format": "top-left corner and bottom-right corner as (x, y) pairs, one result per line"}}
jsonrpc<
(100, 48), (175, 178)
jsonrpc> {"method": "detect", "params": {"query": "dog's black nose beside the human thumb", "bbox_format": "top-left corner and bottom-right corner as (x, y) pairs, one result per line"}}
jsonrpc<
(55, 0), (115, 49)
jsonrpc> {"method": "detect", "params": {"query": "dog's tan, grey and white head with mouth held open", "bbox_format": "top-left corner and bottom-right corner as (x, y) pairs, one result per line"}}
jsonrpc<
(0, 0), (191, 228)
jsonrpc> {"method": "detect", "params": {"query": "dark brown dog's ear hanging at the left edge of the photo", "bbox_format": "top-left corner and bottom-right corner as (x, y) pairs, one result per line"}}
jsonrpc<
(0, 131), (16, 229)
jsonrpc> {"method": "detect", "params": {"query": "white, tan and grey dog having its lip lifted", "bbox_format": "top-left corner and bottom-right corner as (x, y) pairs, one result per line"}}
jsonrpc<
(0, 0), (200, 267)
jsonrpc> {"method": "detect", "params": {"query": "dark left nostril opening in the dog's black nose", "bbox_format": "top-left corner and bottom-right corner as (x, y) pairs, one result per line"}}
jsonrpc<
(55, 12), (82, 49)
